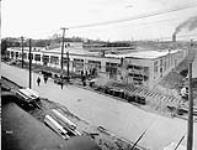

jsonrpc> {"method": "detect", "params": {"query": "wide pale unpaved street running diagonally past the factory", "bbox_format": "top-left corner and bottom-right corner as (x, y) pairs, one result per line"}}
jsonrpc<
(1, 63), (197, 150)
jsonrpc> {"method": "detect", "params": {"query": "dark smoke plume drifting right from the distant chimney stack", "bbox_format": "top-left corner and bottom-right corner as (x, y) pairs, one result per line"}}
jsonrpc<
(174, 16), (197, 35)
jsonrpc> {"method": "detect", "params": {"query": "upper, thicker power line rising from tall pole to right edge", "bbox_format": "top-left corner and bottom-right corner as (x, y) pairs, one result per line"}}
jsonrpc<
(69, 3), (197, 29)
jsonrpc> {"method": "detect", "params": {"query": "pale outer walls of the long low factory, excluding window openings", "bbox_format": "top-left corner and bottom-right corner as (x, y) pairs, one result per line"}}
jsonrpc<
(8, 48), (187, 87)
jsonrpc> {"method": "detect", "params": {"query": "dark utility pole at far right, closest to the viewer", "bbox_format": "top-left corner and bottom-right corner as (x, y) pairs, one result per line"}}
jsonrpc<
(187, 41), (195, 150)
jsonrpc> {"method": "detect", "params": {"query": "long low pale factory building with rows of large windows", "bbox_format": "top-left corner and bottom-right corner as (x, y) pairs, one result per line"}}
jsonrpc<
(7, 43), (187, 87)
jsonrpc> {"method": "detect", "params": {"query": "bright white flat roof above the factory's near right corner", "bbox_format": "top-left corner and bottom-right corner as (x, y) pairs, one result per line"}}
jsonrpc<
(105, 50), (179, 59)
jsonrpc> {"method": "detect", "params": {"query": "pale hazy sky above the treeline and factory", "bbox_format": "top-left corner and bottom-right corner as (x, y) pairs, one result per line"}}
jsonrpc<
(1, 0), (197, 41)
